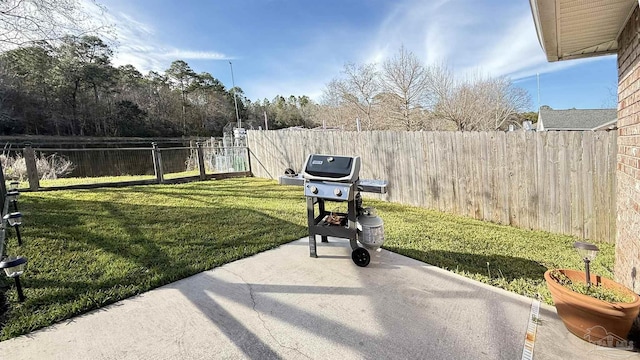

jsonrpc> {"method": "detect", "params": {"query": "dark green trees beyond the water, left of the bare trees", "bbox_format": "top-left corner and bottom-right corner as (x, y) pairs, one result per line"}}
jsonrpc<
(0, 35), (322, 136)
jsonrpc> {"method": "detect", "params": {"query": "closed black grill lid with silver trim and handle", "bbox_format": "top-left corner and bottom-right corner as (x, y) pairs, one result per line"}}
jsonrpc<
(302, 154), (360, 182)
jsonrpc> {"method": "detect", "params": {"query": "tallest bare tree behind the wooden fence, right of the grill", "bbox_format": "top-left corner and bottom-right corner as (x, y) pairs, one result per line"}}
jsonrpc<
(382, 46), (432, 131)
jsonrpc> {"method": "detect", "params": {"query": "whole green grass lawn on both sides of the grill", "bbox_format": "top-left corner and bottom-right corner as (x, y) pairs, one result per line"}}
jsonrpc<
(0, 178), (614, 339)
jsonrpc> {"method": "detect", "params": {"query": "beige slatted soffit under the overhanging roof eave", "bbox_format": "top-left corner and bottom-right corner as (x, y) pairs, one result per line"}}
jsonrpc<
(529, 0), (638, 61)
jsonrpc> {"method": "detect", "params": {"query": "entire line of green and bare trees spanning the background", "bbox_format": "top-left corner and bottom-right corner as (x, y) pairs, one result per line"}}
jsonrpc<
(0, 35), (531, 137)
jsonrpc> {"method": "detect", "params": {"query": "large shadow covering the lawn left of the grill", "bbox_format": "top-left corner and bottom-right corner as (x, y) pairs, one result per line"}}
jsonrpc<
(0, 194), (307, 340)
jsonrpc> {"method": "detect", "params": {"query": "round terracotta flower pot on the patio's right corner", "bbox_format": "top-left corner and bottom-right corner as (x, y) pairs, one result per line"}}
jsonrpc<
(544, 269), (640, 347)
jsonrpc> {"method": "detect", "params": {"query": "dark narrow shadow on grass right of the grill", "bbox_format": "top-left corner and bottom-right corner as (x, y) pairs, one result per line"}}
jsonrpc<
(385, 246), (547, 281)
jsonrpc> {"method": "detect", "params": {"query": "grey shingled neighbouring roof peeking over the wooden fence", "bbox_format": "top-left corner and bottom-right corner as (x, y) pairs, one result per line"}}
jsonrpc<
(536, 109), (618, 131)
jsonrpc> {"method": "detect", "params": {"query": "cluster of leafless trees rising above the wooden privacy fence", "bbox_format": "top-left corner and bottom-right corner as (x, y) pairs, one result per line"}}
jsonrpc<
(322, 46), (532, 131)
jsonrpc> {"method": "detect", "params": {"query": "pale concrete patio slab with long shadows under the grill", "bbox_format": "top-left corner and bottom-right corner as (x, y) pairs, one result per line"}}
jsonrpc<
(0, 238), (640, 360)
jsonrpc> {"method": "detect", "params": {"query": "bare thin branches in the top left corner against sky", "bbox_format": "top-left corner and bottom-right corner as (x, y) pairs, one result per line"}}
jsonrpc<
(0, 0), (109, 50)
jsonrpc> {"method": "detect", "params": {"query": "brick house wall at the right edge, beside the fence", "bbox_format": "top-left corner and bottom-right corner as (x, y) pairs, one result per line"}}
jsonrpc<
(615, 7), (640, 293)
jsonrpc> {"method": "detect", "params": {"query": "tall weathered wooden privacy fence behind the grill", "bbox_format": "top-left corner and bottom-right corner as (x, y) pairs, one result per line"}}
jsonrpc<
(248, 131), (617, 242)
